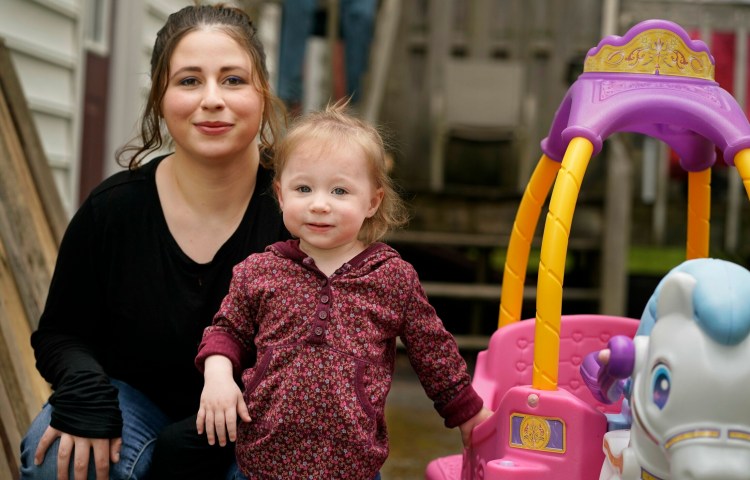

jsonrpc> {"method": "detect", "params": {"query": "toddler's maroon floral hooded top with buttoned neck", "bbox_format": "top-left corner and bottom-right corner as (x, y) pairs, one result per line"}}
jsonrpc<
(196, 240), (482, 479)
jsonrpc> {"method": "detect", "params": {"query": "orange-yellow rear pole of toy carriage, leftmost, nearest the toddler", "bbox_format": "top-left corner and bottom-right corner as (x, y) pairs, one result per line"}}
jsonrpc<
(497, 154), (560, 328)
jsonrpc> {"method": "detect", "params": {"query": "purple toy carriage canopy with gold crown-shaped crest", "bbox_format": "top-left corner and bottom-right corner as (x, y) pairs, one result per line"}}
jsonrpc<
(541, 20), (750, 171)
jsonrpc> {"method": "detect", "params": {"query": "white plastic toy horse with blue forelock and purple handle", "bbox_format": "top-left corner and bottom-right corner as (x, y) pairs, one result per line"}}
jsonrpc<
(581, 259), (750, 480)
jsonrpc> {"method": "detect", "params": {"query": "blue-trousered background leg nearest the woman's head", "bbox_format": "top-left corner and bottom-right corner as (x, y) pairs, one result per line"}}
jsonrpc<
(278, 0), (317, 110)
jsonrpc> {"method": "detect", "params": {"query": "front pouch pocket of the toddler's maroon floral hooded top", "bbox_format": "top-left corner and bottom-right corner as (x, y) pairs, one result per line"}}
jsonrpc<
(243, 343), (387, 445)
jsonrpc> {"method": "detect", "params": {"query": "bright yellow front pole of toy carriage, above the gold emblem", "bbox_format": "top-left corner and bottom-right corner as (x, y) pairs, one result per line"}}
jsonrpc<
(532, 137), (594, 390)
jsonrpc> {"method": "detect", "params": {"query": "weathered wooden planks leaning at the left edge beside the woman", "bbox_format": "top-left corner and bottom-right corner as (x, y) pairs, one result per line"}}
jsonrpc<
(0, 34), (56, 479)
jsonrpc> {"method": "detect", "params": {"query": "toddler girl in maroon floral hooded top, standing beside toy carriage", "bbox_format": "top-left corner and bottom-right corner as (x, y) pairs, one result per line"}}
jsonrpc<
(196, 104), (491, 479)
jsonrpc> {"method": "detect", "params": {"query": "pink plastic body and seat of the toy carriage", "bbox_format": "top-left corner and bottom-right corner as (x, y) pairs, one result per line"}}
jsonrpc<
(425, 315), (638, 480)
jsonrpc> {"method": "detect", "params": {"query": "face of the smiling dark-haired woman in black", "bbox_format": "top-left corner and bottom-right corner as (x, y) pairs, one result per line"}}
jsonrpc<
(162, 30), (263, 164)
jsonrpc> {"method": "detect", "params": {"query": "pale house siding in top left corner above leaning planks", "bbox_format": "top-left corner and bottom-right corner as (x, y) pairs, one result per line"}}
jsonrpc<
(0, 0), (83, 216)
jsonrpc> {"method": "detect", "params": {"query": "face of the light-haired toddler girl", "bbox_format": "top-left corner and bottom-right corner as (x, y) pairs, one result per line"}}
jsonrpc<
(276, 140), (383, 253)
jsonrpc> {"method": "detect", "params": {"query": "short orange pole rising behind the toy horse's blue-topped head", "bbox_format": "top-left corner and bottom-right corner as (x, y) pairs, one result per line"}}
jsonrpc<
(685, 168), (711, 260)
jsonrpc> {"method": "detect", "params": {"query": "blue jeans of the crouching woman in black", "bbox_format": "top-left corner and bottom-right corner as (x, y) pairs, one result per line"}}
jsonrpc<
(21, 380), (243, 480)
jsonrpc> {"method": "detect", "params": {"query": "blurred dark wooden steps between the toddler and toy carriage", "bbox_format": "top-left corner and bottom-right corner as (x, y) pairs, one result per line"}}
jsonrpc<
(386, 189), (601, 351)
